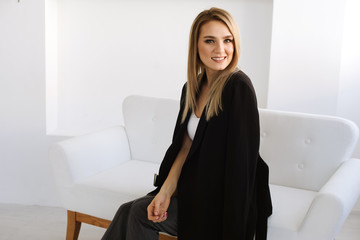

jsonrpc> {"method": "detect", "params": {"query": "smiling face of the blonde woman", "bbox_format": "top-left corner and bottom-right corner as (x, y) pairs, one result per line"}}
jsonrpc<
(198, 20), (234, 78)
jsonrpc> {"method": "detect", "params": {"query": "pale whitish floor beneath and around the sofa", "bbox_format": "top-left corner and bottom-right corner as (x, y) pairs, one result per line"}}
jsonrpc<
(0, 204), (360, 240)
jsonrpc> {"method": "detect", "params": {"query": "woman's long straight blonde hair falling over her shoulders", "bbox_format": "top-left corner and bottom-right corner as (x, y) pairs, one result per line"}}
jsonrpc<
(181, 8), (240, 122)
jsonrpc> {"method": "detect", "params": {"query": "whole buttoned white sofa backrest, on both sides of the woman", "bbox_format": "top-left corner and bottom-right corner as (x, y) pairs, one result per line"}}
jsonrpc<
(123, 96), (358, 191)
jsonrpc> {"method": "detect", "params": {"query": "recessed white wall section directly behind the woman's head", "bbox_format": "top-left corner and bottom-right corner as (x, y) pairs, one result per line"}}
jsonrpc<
(47, 0), (272, 135)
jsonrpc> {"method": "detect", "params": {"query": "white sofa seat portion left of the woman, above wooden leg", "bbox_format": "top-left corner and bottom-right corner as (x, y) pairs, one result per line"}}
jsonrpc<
(64, 160), (159, 220)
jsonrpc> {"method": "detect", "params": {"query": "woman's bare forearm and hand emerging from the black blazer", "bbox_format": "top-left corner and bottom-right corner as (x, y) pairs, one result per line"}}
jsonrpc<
(147, 132), (192, 222)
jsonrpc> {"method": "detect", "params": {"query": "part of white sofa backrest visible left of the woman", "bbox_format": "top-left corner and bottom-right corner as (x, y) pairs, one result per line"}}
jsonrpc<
(123, 95), (180, 163)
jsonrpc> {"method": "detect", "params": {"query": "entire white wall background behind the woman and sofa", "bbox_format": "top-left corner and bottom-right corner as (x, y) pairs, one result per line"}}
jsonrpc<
(0, 0), (360, 208)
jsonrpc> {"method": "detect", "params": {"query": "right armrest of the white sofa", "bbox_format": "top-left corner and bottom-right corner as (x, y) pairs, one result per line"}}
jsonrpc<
(300, 159), (360, 239)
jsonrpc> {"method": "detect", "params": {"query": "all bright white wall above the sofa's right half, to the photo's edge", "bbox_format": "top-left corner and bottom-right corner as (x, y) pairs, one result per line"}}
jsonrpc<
(268, 0), (360, 157)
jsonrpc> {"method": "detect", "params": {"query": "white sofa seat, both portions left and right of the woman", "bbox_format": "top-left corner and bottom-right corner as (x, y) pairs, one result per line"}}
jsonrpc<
(62, 163), (317, 227)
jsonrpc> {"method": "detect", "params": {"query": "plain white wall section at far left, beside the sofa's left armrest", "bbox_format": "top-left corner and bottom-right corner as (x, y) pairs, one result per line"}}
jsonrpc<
(0, 0), (66, 205)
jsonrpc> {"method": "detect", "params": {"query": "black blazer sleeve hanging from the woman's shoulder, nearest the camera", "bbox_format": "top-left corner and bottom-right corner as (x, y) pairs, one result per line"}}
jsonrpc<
(223, 74), (260, 240)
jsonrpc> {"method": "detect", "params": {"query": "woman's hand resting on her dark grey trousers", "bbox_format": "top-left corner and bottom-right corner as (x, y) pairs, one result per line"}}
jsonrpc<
(147, 191), (171, 223)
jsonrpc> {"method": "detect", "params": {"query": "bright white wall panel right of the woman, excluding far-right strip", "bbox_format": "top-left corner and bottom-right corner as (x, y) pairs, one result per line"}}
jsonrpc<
(268, 0), (345, 115)
